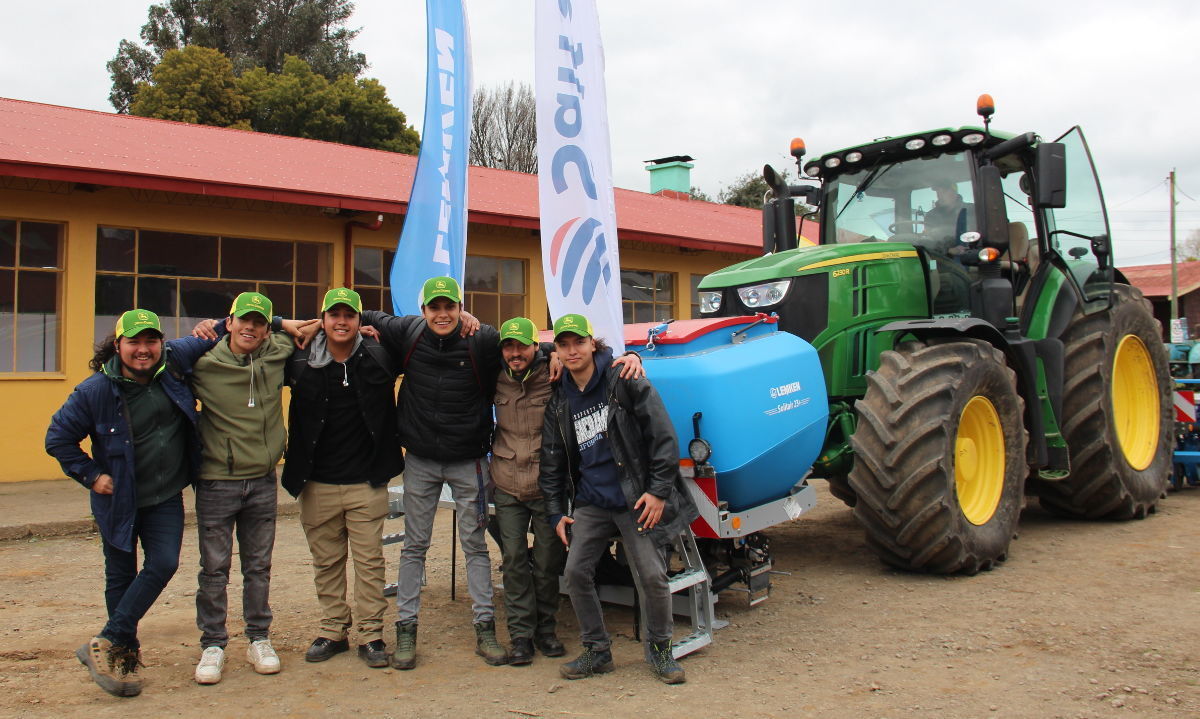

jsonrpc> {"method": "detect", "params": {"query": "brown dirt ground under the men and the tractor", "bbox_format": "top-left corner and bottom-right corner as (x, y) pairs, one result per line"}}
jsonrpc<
(0, 483), (1200, 719)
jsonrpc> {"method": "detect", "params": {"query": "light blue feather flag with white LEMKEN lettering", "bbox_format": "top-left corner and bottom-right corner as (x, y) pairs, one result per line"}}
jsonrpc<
(391, 0), (472, 314)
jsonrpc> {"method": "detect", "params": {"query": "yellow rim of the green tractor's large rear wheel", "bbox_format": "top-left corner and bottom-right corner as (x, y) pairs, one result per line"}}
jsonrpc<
(1112, 335), (1162, 471)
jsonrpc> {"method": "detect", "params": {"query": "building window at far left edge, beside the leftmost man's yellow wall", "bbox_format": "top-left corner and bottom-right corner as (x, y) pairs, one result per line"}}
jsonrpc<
(0, 218), (62, 372)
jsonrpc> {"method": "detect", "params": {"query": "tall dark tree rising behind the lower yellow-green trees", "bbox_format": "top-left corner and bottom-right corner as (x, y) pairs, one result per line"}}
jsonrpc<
(107, 0), (367, 113)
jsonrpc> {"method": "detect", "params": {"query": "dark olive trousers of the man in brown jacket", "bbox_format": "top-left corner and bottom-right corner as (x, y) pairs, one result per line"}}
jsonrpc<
(496, 490), (566, 639)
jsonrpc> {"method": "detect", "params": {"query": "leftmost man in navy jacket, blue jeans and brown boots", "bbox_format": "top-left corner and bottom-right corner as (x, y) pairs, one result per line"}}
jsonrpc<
(46, 310), (211, 696)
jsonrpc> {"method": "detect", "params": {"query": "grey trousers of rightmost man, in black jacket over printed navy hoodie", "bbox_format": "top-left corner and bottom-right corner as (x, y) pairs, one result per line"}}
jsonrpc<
(563, 505), (674, 649)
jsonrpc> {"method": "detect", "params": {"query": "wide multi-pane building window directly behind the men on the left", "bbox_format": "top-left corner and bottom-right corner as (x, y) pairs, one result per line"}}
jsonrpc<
(95, 227), (329, 342)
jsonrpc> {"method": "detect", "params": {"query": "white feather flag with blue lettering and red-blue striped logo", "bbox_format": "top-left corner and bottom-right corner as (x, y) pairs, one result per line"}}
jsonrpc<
(534, 0), (625, 354)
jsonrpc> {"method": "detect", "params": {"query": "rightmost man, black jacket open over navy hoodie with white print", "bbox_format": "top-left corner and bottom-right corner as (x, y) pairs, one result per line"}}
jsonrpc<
(538, 314), (698, 684)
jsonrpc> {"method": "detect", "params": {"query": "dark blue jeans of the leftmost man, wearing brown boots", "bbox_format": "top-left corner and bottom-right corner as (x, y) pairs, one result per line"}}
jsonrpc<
(100, 492), (184, 649)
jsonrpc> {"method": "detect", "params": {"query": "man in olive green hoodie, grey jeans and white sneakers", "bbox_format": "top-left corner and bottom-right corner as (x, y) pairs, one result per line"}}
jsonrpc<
(192, 292), (293, 684)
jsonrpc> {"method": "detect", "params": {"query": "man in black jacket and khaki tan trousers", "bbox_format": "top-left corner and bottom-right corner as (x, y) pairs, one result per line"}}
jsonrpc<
(282, 287), (404, 667)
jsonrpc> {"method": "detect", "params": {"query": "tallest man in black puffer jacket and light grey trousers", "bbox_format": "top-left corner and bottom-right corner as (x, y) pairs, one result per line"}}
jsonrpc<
(362, 277), (509, 669)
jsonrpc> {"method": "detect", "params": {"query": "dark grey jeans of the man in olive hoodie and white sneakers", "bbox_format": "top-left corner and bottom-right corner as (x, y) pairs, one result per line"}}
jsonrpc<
(196, 472), (278, 648)
